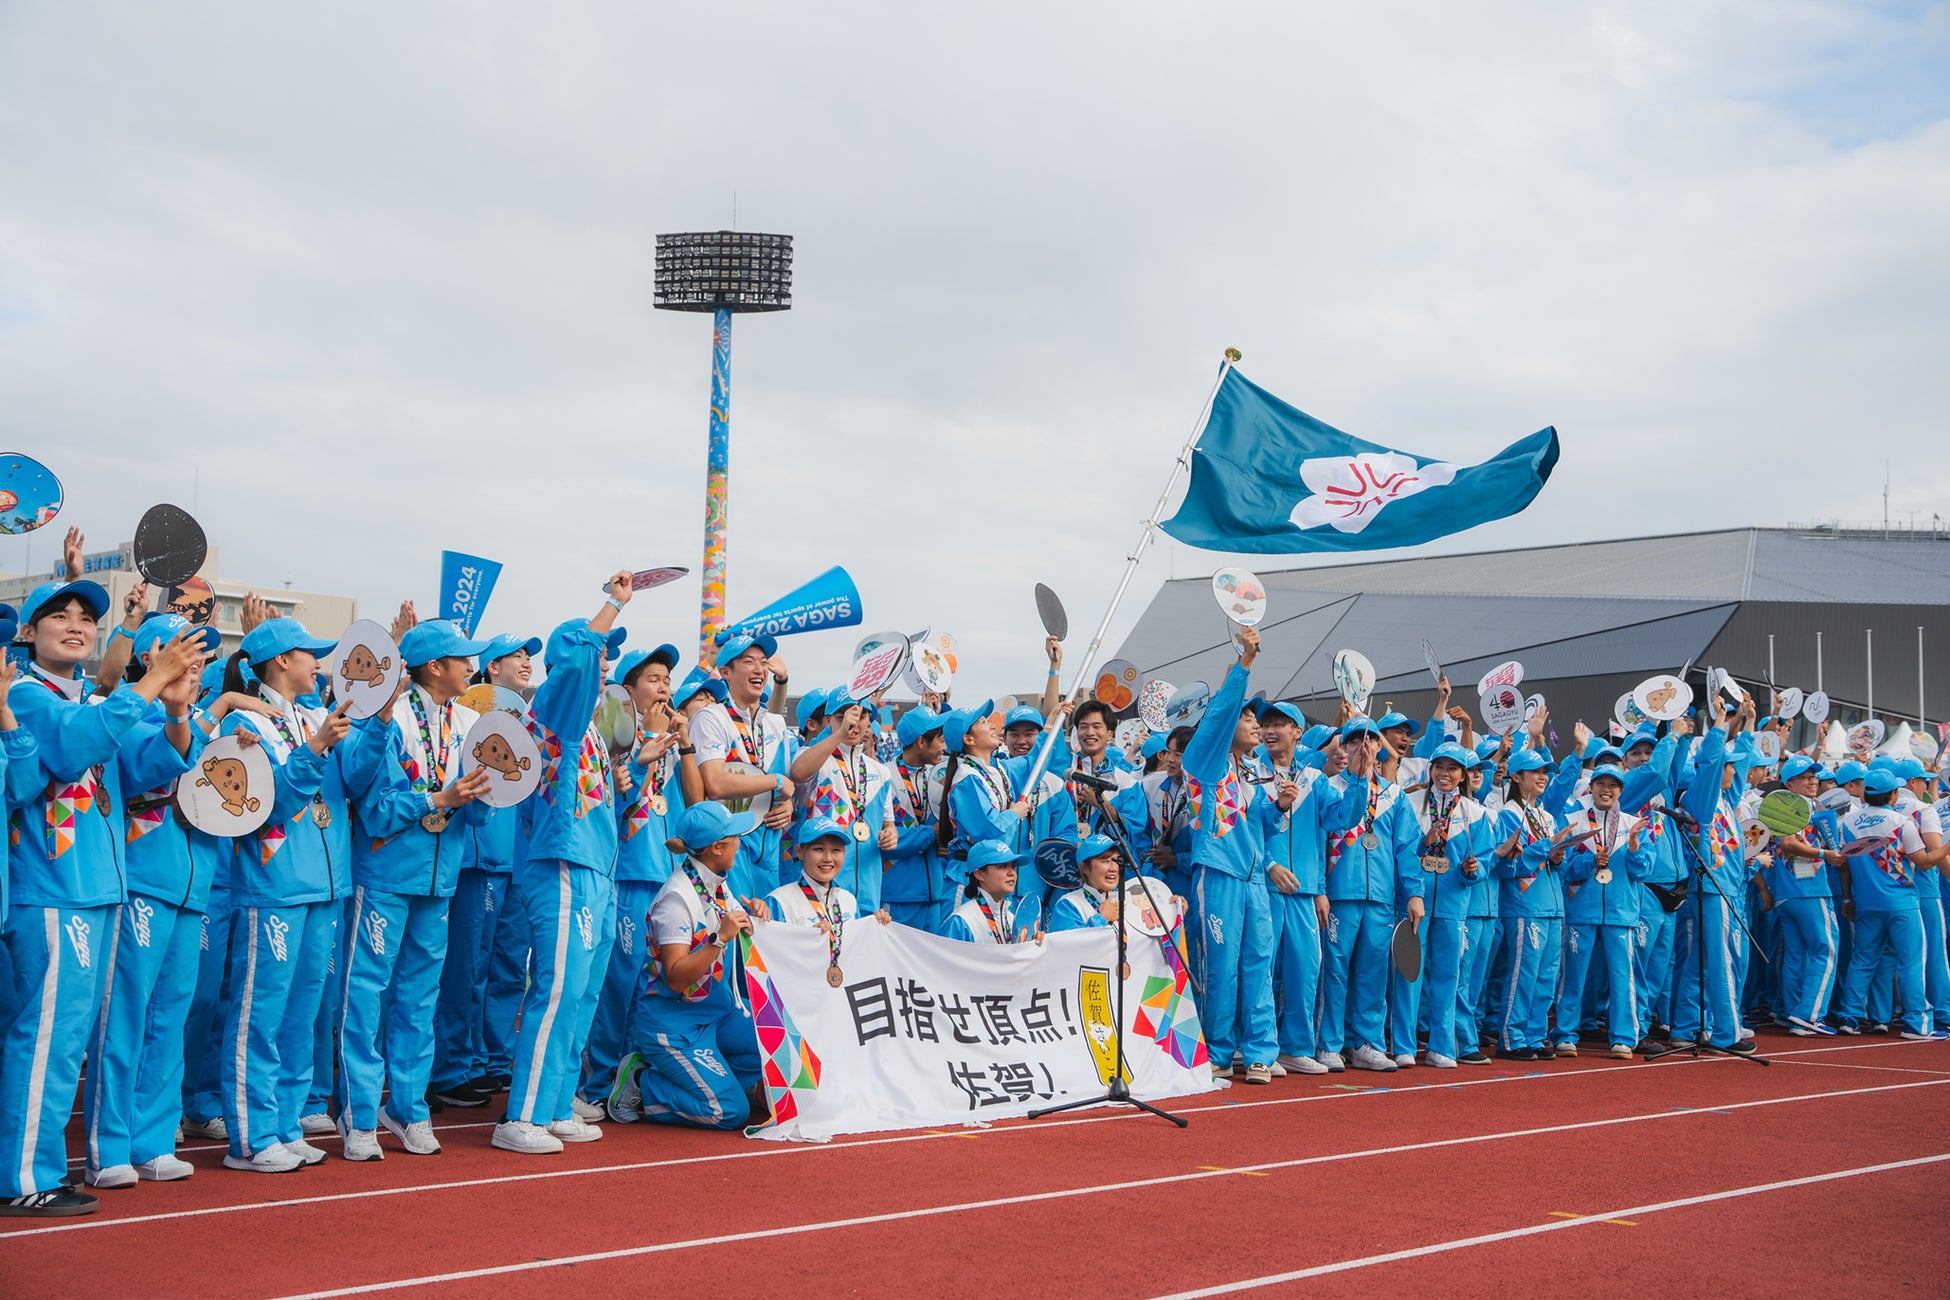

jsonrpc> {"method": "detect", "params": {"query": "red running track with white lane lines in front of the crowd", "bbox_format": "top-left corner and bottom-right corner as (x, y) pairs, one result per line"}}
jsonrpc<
(0, 1035), (1950, 1300)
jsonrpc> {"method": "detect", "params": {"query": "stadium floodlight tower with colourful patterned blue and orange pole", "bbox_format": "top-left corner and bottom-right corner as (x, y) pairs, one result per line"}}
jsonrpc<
(655, 230), (792, 667)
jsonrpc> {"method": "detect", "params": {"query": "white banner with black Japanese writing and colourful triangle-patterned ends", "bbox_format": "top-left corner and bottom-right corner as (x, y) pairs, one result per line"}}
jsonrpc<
(745, 916), (1219, 1140)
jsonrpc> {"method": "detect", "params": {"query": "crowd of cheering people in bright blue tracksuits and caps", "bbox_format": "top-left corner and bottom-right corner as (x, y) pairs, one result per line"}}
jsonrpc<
(0, 537), (1950, 1216)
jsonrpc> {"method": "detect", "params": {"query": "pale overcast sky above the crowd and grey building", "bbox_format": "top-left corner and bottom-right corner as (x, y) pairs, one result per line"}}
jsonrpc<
(0, 0), (1950, 694)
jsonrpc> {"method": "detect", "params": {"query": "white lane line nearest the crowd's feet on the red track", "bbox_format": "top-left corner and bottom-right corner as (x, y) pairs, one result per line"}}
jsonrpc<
(22, 1043), (1923, 1245)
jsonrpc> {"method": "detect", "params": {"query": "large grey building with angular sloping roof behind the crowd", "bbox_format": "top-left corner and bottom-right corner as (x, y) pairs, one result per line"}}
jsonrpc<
(1117, 528), (1950, 725)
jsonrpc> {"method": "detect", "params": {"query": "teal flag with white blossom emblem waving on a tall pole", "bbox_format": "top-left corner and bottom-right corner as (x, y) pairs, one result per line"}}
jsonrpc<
(1162, 370), (1558, 555)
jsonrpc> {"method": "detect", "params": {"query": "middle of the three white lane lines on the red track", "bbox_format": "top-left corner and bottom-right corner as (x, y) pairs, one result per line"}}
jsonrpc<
(259, 1080), (1950, 1300)
